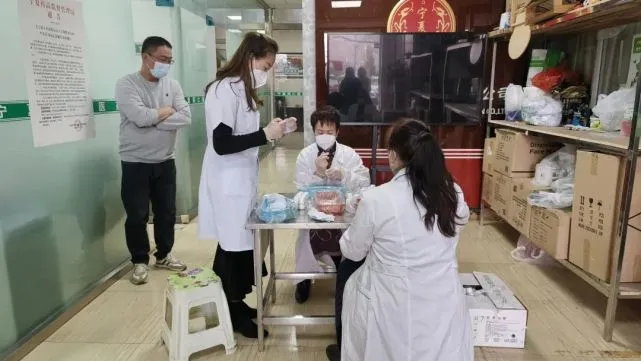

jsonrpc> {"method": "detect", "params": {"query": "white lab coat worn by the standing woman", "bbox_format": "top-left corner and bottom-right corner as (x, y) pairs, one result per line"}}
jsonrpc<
(198, 78), (260, 252)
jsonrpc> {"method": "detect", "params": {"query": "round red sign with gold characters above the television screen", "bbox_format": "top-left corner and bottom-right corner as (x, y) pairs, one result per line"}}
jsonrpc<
(387, 0), (456, 33)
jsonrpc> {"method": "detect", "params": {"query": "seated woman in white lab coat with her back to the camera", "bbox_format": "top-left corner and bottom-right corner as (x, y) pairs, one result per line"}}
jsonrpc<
(340, 120), (474, 361)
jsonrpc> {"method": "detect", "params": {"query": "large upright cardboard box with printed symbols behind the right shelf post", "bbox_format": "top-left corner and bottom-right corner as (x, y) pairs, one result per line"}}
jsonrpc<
(568, 151), (641, 282)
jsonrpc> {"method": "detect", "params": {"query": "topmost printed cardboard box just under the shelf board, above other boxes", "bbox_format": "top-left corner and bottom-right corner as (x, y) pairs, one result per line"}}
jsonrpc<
(492, 129), (560, 178)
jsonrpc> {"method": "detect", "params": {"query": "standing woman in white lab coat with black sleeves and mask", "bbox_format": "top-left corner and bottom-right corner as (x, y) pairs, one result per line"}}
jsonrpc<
(198, 32), (285, 338)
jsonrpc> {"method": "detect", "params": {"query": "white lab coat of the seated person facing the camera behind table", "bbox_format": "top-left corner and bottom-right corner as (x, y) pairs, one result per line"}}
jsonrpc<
(294, 143), (370, 276)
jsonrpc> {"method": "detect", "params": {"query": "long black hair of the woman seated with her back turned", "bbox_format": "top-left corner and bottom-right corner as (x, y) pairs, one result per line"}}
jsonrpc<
(387, 119), (460, 237)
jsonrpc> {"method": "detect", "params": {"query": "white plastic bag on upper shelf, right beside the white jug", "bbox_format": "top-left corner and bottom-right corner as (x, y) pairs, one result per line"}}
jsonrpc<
(521, 86), (563, 127)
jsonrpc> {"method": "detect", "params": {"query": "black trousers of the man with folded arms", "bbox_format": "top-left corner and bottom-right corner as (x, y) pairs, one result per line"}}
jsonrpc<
(121, 159), (176, 264)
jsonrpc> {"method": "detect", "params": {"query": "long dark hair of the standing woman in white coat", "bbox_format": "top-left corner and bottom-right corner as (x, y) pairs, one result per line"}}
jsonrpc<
(205, 32), (278, 111)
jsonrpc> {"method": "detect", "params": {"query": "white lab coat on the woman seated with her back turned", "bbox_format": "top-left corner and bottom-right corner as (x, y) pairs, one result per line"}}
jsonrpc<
(340, 171), (474, 361)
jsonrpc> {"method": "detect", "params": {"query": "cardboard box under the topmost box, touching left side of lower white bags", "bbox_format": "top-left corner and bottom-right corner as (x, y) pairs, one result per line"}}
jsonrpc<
(506, 178), (541, 238)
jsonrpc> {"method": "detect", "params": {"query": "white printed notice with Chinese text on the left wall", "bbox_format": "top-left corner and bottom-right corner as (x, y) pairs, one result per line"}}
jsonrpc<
(18, 0), (96, 147)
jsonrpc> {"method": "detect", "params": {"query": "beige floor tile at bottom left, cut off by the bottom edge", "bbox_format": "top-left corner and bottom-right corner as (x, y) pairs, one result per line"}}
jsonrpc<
(22, 342), (138, 361)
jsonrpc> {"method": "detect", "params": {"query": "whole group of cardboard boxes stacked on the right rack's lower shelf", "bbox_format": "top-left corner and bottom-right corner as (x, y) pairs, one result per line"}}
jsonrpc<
(482, 129), (641, 282)
